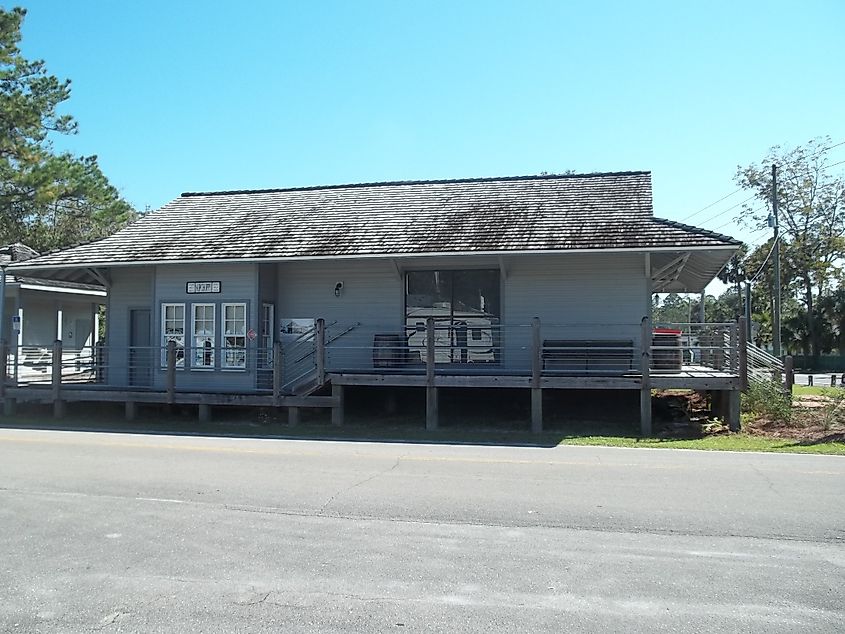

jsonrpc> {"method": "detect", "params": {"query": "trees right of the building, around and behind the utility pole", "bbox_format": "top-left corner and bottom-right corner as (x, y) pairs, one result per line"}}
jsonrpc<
(653, 137), (845, 358)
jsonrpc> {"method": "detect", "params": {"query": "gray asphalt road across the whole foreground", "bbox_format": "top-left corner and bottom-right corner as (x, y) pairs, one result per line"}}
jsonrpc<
(0, 429), (845, 634)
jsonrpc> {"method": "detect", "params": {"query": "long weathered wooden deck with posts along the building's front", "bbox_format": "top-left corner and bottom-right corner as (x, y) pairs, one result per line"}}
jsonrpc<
(0, 320), (747, 436)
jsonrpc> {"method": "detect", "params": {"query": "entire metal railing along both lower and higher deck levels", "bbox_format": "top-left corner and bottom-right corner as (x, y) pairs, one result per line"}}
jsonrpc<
(0, 318), (740, 395)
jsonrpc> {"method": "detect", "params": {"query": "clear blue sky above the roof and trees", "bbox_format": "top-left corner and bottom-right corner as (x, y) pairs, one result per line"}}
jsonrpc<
(13, 0), (845, 256)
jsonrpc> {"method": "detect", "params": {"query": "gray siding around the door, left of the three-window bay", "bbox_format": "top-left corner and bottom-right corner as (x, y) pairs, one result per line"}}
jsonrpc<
(106, 267), (155, 386)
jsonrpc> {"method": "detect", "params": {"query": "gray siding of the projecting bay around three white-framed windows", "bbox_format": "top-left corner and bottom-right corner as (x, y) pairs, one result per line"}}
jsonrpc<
(151, 262), (260, 391)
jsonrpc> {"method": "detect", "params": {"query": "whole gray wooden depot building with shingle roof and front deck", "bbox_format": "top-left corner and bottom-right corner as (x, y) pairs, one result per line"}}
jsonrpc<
(10, 172), (741, 429)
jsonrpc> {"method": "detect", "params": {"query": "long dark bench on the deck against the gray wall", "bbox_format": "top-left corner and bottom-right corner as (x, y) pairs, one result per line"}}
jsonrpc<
(542, 339), (634, 374)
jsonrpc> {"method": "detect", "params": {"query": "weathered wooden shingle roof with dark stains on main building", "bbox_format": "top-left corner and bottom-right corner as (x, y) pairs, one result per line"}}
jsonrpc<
(11, 172), (739, 267)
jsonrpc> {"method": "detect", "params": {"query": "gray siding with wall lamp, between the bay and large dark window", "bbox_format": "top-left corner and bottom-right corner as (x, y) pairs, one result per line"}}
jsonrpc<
(276, 260), (405, 369)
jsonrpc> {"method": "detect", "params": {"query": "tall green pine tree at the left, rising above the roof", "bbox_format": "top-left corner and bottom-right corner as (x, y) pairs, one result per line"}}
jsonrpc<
(0, 8), (137, 252)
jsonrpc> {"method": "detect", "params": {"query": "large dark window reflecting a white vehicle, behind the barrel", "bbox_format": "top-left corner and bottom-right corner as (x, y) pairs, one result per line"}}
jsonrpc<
(405, 269), (501, 363)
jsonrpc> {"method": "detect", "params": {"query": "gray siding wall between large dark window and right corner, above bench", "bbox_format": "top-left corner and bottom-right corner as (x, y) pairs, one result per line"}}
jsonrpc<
(502, 253), (651, 367)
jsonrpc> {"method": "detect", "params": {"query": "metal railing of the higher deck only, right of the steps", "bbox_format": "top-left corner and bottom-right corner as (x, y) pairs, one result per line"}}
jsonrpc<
(326, 318), (739, 376)
